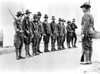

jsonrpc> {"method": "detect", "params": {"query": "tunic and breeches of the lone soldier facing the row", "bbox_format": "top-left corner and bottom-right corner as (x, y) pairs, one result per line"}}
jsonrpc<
(81, 12), (94, 51)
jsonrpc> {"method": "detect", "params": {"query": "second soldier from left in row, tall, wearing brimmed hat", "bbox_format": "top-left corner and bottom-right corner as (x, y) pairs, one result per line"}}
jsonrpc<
(23, 10), (31, 57)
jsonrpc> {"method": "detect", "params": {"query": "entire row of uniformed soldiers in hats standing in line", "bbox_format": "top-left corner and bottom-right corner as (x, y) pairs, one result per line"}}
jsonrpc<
(14, 10), (77, 60)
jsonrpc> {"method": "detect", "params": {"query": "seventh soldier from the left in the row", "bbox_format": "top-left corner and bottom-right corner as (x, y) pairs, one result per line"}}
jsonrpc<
(57, 18), (63, 50)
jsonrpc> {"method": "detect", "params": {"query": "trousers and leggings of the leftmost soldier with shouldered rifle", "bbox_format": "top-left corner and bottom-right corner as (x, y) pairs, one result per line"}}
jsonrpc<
(14, 34), (23, 57)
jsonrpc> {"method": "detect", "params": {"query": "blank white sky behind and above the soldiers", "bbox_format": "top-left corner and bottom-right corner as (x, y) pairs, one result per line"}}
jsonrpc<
(0, 0), (100, 46)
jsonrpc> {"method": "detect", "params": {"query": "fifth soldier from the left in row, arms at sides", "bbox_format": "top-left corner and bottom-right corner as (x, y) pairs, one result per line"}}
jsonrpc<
(43, 14), (51, 52)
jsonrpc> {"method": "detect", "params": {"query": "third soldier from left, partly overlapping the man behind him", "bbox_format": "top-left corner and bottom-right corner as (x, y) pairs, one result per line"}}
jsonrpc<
(31, 14), (40, 55)
